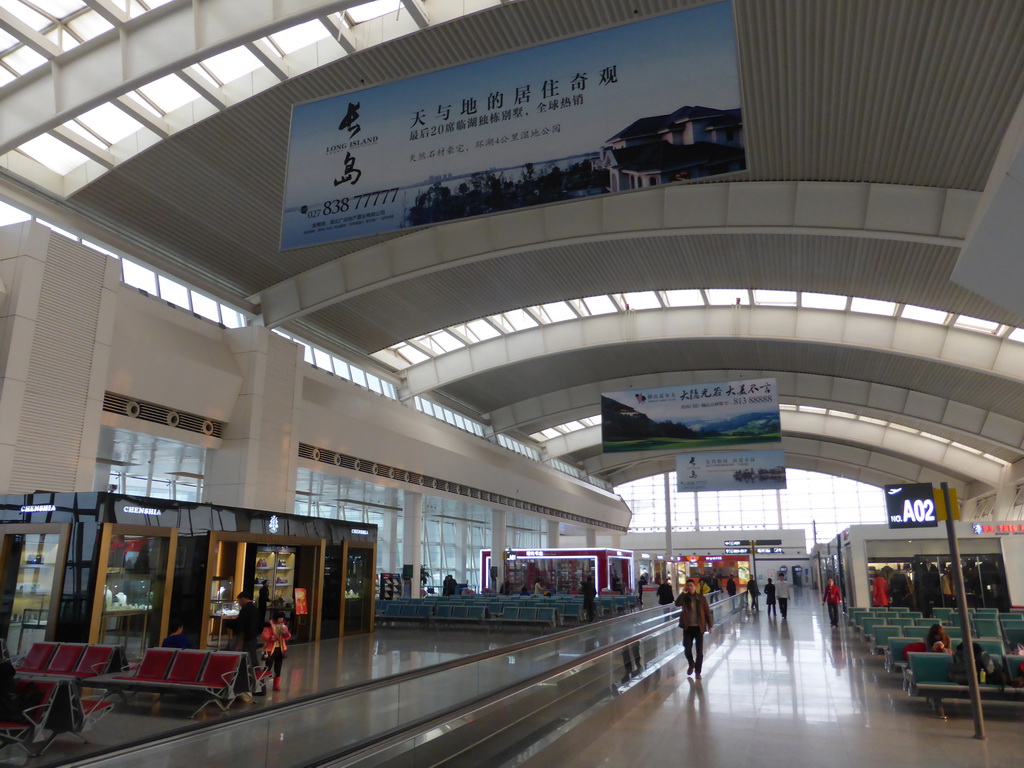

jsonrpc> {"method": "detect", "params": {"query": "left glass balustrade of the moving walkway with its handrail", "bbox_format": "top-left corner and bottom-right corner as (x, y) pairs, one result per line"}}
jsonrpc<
(61, 606), (696, 768)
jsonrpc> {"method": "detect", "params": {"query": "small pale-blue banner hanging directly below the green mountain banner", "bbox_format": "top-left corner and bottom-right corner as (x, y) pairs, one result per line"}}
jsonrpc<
(676, 451), (785, 493)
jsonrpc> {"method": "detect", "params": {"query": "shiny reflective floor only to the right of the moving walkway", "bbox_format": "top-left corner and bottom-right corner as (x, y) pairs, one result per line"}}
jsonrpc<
(515, 590), (1024, 768)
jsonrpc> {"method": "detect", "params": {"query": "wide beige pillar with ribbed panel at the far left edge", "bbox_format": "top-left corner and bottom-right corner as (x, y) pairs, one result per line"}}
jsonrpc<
(0, 221), (120, 494)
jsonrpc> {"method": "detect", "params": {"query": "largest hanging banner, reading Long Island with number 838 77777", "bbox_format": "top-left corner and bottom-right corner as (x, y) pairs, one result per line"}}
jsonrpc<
(281, 2), (745, 249)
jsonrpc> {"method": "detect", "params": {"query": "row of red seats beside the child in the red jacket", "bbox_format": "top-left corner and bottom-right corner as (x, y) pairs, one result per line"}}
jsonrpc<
(86, 648), (271, 717)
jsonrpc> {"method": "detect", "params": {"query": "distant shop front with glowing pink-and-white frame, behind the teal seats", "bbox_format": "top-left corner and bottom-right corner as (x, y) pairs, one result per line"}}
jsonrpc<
(480, 549), (636, 594)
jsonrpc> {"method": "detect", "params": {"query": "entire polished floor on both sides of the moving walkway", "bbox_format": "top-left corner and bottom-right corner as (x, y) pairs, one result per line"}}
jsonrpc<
(9, 590), (1024, 768)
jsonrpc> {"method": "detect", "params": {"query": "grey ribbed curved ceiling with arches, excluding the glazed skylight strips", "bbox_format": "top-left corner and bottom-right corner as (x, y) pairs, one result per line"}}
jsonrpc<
(0, 0), (1024, 493)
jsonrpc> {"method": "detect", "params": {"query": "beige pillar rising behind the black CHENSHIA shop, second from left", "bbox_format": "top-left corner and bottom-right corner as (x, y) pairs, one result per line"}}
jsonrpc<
(203, 326), (302, 512)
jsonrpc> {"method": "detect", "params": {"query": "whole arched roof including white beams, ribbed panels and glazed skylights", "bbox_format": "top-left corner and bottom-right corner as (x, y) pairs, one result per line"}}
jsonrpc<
(0, 0), (1024, 495)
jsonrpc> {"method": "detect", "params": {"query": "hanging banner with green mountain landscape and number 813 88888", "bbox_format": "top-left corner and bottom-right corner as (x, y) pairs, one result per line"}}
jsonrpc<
(601, 379), (782, 454)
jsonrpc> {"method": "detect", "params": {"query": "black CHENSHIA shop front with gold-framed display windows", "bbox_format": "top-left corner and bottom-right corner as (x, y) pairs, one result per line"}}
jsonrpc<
(0, 493), (377, 656)
